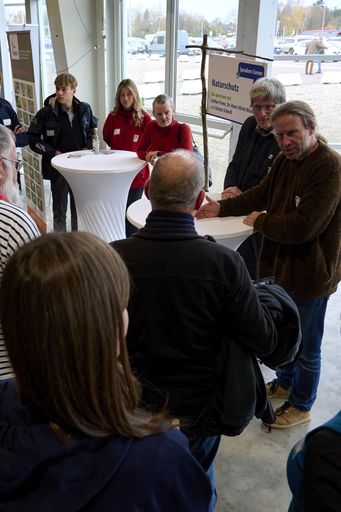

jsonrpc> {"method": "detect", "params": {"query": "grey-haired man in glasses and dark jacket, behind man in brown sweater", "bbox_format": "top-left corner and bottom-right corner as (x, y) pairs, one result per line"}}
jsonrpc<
(222, 78), (285, 279)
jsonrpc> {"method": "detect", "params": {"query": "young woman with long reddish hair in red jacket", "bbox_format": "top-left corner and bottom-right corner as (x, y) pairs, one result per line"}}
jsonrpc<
(103, 78), (151, 237)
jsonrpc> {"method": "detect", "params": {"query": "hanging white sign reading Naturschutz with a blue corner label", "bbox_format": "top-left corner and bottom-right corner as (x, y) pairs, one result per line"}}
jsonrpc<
(207, 55), (267, 124)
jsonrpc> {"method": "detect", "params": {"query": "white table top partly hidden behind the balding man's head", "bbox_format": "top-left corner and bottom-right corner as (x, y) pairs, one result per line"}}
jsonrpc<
(127, 193), (253, 240)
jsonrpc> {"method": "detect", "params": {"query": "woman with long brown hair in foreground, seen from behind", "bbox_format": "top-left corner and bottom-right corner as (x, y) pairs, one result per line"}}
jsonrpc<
(0, 232), (211, 512)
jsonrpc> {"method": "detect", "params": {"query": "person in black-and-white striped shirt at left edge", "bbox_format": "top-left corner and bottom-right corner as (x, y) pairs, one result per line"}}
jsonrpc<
(0, 125), (39, 380)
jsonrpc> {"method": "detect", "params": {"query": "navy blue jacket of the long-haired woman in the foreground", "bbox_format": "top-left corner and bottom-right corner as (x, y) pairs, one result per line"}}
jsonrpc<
(0, 381), (211, 512)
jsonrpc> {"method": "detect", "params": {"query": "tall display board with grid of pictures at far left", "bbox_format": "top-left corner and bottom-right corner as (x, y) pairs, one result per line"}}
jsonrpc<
(7, 30), (46, 231)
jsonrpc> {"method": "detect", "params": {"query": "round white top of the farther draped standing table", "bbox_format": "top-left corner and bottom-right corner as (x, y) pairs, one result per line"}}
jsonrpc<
(51, 149), (146, 174)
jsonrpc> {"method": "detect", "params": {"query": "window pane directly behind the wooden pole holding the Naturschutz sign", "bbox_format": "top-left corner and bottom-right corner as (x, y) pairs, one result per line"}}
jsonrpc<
(176, 0), (238, 192)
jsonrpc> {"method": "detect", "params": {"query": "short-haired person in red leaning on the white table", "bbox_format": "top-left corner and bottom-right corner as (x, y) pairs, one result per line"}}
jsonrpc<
(137, 94), (193, 164)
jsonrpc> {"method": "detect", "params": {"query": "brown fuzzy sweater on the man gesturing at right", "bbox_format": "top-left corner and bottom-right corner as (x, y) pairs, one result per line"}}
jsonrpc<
(219, 143), (341, 299)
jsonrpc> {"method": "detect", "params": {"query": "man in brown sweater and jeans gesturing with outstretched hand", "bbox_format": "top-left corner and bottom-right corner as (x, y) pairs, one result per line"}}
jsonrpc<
(197, 101), (341, 428)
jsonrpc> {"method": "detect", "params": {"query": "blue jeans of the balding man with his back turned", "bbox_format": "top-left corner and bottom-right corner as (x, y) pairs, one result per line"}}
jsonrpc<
(181, 429), (221, 512)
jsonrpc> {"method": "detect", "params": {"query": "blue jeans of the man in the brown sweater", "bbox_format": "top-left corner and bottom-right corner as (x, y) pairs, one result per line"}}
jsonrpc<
(276, 297), (329, 411)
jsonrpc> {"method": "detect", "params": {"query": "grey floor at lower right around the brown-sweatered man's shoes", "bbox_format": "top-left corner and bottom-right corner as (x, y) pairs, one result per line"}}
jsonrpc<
(216, 286), (341, 512)
